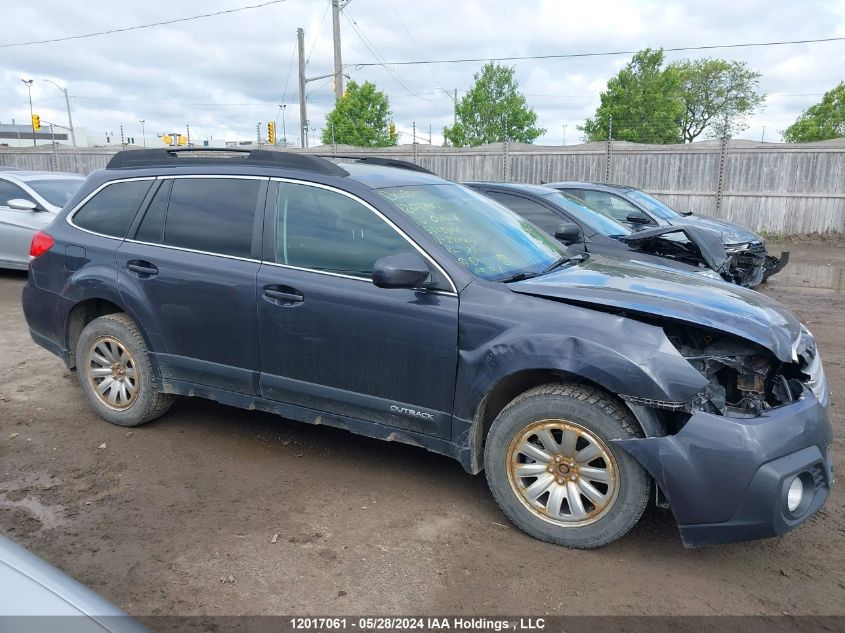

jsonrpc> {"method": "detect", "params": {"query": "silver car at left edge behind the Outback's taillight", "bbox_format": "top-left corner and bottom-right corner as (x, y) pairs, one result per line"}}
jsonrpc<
(0, 167), (85, 270)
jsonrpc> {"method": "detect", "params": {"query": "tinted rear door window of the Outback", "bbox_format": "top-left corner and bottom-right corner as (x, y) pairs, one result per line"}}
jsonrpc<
(161, 178), (262, 257)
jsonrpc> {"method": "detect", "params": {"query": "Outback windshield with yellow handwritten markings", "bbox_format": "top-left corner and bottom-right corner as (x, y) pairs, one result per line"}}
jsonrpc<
(378, 184), (566, 281)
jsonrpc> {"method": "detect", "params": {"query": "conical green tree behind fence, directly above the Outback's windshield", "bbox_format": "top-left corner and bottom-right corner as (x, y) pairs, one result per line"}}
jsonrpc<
(443, 62), (546, 147)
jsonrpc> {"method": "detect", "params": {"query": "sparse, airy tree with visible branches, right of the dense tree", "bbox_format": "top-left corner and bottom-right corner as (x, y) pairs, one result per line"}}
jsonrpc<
(667, 59), (766, 143)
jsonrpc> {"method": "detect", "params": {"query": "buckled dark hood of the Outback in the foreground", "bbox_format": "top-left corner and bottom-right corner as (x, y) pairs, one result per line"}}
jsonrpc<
(508, 255), (801, 363)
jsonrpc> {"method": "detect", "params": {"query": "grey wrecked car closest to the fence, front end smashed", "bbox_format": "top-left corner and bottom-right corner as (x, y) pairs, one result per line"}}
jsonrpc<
(547, 182), (789, 287)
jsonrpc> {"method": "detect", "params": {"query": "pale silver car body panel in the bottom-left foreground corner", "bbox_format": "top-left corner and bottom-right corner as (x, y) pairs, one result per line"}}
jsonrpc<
(0, 535), (149, 633)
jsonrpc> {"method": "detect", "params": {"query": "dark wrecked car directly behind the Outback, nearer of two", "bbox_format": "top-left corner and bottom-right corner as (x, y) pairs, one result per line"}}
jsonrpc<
(463, 182), (727, 279)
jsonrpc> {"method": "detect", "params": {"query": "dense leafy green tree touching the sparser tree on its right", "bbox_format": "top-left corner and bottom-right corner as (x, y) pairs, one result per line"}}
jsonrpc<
(578, 48), (684, 143)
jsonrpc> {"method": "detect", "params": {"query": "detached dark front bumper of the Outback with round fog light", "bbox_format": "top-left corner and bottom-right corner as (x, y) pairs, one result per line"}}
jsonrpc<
(614, 388), (833, 547)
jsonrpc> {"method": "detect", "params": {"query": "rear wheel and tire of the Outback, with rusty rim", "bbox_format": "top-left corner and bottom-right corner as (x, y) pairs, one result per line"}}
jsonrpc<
(76, 312), (173, 426)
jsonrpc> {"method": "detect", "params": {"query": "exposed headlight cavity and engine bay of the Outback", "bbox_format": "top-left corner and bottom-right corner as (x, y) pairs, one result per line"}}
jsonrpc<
(664, 325), (817, 417)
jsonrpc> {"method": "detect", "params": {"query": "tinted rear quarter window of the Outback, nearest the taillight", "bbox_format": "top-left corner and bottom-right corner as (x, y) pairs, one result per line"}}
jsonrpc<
(72, 180), (153, 237)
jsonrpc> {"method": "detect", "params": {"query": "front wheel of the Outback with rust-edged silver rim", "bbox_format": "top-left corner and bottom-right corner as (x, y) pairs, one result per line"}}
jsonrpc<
(484, 384), (651, 549)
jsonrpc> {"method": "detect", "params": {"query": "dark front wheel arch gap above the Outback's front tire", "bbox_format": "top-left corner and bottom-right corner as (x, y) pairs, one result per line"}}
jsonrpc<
(472, 369), (628, 473)
